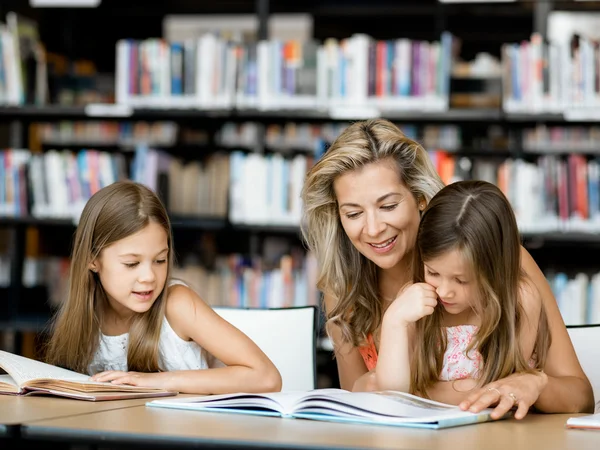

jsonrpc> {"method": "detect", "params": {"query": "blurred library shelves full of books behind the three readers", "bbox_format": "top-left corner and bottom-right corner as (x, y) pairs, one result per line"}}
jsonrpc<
(0, 7), (600, 356)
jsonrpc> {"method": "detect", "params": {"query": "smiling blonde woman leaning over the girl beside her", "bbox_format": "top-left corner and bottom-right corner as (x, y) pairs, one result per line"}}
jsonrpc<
(302, 119), (593, 418)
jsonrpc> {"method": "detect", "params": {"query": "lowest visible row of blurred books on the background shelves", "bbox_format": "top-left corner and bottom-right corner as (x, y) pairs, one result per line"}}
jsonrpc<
(5, 252), (600, 325)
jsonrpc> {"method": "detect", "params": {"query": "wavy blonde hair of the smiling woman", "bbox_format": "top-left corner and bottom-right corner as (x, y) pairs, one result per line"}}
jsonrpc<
(302, 119), (444, 346)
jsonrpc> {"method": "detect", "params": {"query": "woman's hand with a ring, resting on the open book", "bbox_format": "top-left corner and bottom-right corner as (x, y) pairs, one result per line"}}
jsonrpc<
(459, 372), (548, 419)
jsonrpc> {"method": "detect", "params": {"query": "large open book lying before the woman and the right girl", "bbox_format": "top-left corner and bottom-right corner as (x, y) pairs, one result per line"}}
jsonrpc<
(146, 389), (506, 428)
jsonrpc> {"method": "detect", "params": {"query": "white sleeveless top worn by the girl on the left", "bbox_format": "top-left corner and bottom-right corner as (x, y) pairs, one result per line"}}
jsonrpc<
(88, 280), (208, 375)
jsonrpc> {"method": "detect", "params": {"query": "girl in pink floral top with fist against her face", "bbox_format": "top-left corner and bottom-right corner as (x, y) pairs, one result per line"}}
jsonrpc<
(376, 181), (551, 413)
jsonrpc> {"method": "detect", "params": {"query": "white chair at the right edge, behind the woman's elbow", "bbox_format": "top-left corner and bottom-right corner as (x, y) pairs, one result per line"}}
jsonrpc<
(567, 324), (600, 412)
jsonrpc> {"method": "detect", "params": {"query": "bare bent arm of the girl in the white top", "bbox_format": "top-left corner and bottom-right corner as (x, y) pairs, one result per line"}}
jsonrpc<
(97, 285), (281, 394)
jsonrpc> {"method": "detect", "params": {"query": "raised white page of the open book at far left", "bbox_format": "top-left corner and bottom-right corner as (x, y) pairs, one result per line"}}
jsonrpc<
(0, 350), (90, 387)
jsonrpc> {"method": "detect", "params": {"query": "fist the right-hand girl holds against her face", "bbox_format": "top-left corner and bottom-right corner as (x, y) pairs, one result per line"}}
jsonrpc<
(384, 283), (438, 326)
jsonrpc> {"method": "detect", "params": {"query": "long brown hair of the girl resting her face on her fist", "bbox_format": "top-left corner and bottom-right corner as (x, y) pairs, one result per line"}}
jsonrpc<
(411, 181), (550, 395)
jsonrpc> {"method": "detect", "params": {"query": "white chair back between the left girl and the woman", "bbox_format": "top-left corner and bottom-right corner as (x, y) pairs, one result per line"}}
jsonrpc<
(213, 306), (318, 391)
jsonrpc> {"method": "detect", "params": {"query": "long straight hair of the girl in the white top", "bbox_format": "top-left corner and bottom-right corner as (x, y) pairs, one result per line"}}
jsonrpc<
(45, 180), (173, 373)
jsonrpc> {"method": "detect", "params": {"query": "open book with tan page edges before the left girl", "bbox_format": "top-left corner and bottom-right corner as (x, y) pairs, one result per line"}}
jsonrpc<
(0, 350), (177, 401)
